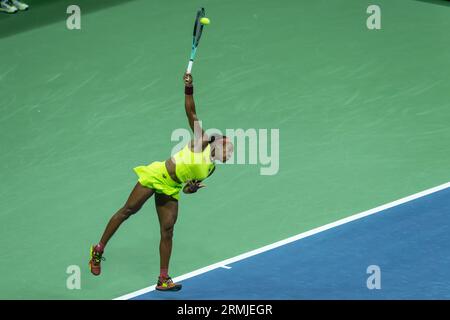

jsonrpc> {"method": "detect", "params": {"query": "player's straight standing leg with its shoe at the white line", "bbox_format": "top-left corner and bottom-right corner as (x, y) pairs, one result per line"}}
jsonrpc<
(155, 193), (181, 291)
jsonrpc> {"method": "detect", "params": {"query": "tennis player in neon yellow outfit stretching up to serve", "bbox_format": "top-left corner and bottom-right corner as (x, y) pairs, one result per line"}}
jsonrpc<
(89, 73), (233, 291)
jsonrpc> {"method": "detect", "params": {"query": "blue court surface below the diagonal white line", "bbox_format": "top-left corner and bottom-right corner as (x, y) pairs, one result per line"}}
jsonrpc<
(133, 188), (450, 300)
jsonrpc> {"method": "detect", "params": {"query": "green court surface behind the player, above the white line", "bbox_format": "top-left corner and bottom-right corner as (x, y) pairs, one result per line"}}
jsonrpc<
(0, 0), (450, 299)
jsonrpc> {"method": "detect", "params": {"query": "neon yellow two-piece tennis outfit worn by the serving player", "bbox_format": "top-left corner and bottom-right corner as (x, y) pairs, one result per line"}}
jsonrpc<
(133, 144), (215, 200)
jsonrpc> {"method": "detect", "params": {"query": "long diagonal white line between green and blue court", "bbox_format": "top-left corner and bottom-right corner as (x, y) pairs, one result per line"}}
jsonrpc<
(114, 182), (450, 300)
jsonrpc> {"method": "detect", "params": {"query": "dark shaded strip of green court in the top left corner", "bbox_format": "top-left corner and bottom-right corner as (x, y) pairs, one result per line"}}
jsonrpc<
(0, 0), (139, 39)
